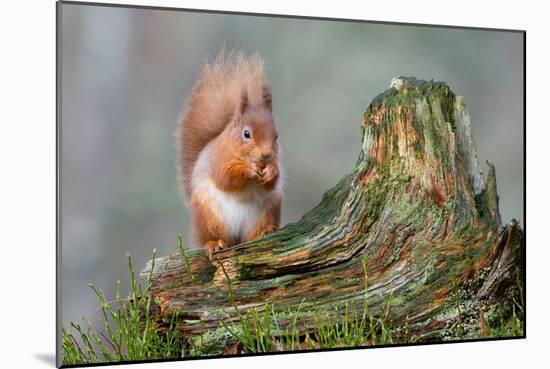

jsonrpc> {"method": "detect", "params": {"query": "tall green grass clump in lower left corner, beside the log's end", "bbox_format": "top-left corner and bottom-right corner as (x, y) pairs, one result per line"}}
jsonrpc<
(62, 251), (185, 365)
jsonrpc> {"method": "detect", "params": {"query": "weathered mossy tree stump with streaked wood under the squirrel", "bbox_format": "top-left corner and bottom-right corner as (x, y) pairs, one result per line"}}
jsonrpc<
(142, 78), (523, 346)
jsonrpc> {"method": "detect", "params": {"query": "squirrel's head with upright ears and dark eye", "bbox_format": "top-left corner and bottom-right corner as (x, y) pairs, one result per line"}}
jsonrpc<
(227, 85), (279, 168)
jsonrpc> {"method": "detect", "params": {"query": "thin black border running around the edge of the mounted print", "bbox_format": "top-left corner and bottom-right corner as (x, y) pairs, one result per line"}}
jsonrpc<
(55, 0), (527, 368)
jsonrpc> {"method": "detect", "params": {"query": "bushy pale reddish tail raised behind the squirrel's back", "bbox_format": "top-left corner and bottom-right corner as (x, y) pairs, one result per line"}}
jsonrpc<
(177, 51), (270, 199)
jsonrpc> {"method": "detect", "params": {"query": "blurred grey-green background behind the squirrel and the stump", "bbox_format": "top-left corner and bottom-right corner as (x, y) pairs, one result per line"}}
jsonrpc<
(59, 4), (524, 325)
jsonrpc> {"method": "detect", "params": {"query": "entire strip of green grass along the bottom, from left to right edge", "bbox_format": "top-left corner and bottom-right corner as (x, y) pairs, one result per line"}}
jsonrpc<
(62, 246), (524, 365)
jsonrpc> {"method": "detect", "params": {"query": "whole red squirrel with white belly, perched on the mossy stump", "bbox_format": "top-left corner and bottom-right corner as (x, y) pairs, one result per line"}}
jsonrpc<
(177, 52), (283, 260)
